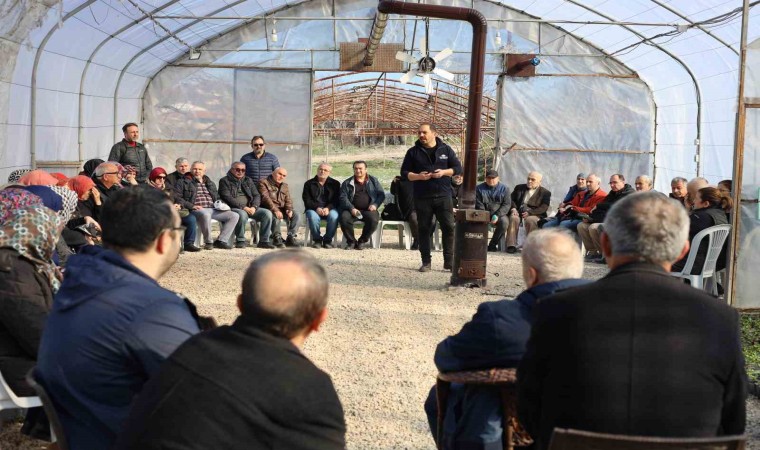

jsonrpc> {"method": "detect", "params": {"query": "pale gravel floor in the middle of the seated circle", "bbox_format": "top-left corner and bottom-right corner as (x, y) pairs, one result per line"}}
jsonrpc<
(0, 232), (760, 450)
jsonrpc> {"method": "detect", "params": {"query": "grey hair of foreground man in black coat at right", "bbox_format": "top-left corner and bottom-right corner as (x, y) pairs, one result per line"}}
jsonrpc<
(604, 192), (689, 264)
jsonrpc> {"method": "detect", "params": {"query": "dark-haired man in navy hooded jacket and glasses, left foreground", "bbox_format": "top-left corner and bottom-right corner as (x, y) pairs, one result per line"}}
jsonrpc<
(36, 185), (200, 449)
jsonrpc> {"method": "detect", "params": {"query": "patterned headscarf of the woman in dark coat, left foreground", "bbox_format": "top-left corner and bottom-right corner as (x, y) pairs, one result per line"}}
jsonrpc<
(0, 205), (63, 293)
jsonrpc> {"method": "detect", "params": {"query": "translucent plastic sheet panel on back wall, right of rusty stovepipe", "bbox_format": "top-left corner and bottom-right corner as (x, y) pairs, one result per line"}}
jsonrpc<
(498, 76), (654, 205)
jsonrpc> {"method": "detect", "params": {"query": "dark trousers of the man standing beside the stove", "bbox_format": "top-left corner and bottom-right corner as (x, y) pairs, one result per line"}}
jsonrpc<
(414, 195), (454, 269)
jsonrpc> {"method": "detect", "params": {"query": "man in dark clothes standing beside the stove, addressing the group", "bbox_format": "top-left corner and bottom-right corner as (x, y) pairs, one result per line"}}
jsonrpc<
(401, 123), (462, 272)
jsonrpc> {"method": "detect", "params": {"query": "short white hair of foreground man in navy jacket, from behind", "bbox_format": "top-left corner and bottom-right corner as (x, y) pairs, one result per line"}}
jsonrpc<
(522, 228), (583, 283)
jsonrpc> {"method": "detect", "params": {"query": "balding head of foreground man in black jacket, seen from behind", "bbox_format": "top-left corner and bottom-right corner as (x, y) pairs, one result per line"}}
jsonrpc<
(240, 249), (329, 339)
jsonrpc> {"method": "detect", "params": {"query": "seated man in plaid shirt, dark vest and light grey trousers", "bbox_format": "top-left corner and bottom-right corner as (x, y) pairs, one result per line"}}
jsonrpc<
(174, 161), (239, 250)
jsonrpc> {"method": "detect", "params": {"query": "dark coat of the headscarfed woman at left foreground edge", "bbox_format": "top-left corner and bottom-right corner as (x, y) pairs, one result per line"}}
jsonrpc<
(0, 248), (53, 397)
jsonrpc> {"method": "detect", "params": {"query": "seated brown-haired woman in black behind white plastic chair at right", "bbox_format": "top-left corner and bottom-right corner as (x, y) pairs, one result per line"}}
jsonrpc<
(670, 187), (733, 275)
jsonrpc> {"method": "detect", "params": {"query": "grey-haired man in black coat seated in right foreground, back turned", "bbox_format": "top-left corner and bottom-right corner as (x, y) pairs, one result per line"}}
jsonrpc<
(517, 192), (747, 450)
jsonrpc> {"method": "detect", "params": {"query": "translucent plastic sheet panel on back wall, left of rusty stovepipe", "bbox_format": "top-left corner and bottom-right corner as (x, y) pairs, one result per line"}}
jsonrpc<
(143, 67), (312, 210)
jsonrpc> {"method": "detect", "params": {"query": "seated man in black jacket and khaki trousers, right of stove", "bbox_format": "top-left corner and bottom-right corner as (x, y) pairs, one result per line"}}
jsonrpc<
(507, 172), (552, 253)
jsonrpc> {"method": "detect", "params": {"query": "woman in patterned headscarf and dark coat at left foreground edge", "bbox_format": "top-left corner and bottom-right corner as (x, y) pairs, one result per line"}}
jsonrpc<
(0, 189), (62, 439)
